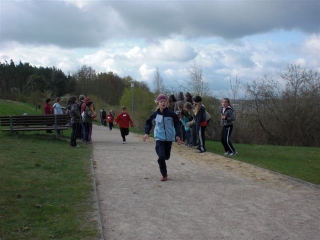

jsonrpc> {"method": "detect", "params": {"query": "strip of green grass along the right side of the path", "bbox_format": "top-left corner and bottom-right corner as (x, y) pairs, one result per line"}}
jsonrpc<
(206, 141), (320, 184)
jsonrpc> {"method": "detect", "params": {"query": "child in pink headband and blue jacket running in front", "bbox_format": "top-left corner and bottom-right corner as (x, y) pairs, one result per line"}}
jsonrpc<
(142, 94), (180, 181)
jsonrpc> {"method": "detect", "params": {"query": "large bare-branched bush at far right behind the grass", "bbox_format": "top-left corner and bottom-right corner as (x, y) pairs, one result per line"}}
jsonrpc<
(247, 65), (320, 146)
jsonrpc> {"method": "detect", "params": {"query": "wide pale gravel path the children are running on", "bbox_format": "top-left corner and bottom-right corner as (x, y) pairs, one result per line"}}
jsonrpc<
(93, 126), (320, 240)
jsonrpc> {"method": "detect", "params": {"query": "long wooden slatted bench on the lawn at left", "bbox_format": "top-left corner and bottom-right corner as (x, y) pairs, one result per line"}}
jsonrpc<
(0, 114), (70, 137)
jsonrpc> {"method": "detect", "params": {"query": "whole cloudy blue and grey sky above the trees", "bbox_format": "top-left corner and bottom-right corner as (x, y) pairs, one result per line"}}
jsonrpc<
(0, 0), (320, 96)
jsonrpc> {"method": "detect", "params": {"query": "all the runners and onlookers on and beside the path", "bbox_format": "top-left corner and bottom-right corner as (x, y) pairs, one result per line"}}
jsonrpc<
(44, 92), (237, 181)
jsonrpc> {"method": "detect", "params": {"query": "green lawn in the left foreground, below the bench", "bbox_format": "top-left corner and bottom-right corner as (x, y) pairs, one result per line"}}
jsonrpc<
(0, 133), (98, 240)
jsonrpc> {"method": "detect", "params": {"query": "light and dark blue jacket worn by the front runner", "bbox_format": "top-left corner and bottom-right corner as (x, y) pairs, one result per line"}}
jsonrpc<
(144, 108), (180, 142)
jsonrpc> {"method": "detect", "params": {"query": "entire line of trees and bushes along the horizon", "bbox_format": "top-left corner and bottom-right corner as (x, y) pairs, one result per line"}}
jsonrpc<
(0, 60), (320, 147)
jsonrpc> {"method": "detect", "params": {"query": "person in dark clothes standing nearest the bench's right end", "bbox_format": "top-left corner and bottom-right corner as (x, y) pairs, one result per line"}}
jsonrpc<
(69, 96), (81, 147)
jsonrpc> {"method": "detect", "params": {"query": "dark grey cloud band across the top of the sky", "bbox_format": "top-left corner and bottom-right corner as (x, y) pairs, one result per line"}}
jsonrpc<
(0, 0), (320, 48)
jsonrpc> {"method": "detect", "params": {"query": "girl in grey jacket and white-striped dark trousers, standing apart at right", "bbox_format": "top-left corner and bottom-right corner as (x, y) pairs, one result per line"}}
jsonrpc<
(221, 98), (238, 156)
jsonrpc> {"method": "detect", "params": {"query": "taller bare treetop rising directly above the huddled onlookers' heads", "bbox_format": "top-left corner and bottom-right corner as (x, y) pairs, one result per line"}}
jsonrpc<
(187, 62), (209, 96)
